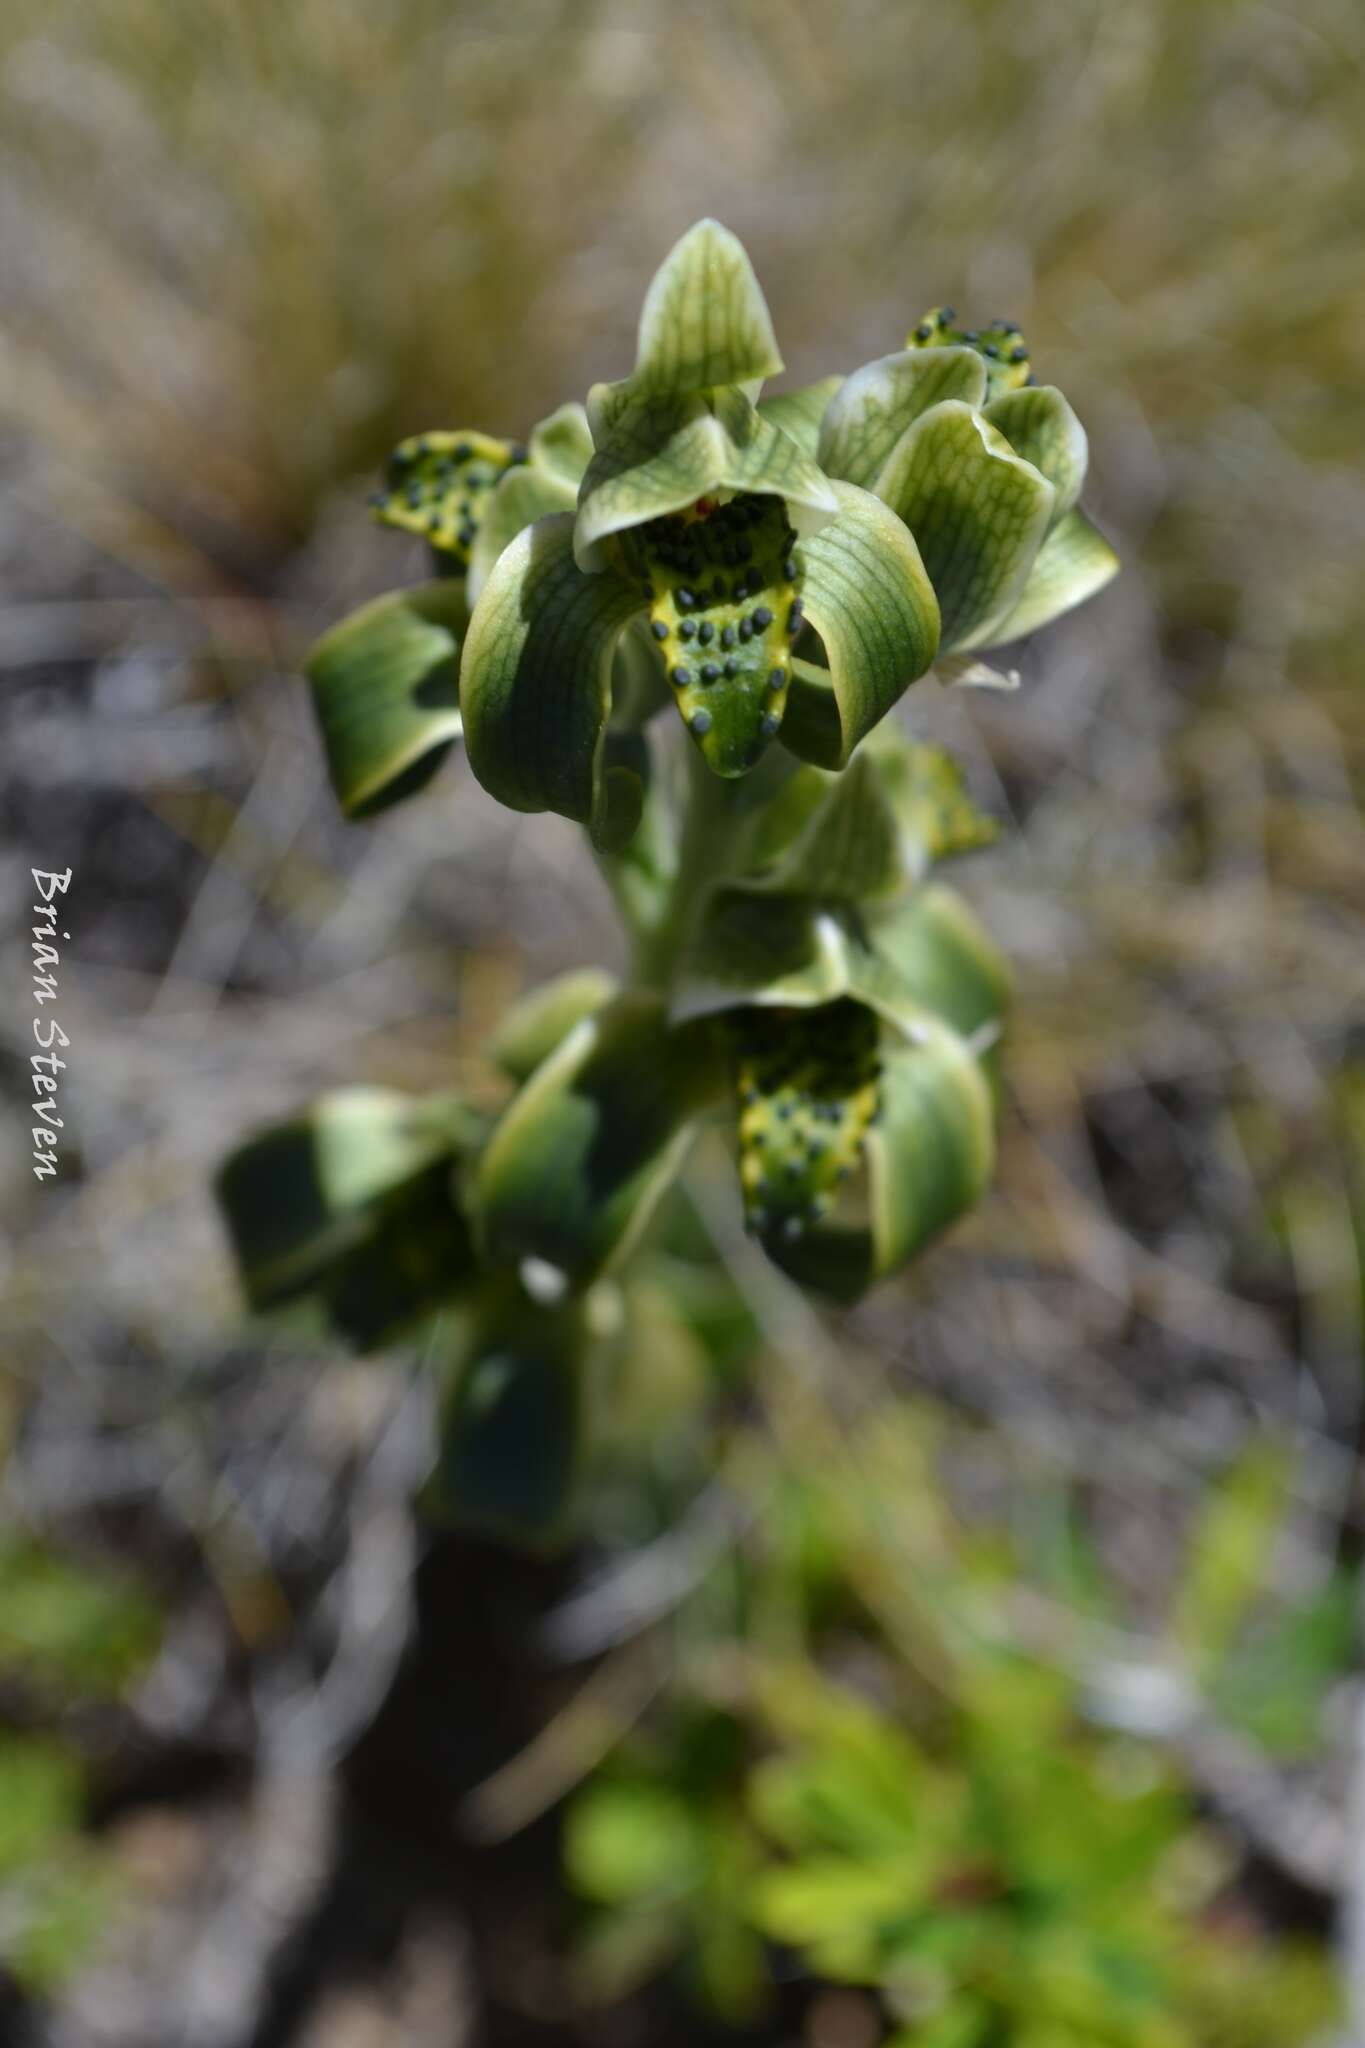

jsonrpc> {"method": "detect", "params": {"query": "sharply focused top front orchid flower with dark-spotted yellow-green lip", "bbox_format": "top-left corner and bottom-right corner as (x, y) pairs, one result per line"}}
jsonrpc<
(460, 221), (937, 848)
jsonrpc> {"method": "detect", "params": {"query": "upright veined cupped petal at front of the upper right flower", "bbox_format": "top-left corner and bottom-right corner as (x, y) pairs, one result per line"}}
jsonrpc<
(876, 399), (1054, 653)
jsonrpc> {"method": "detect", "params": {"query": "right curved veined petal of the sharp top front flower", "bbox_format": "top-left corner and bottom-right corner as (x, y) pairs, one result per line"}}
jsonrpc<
(782, 483), (939, 768)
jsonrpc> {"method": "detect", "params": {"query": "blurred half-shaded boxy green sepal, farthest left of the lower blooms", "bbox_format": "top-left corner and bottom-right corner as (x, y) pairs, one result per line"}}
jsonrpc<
(217, 1087), (483, 1346)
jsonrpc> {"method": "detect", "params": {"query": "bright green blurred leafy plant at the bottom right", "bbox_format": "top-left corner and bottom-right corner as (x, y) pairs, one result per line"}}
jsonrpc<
(563, 1407), (1347, 2048)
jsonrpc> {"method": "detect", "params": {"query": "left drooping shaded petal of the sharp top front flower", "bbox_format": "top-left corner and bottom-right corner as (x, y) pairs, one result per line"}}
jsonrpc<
(460, 514), (643, 848)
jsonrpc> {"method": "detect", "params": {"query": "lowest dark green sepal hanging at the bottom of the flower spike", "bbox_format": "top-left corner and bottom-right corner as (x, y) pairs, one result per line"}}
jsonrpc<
(422, 1276), (593, 1550)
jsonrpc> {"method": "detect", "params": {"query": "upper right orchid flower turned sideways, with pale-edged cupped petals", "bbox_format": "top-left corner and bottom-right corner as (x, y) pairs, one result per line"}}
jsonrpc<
(817, 307), (1117, 655)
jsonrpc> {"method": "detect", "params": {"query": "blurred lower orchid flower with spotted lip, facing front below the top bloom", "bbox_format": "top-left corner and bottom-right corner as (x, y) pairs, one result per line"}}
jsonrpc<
(475, 735), (1007, 1296)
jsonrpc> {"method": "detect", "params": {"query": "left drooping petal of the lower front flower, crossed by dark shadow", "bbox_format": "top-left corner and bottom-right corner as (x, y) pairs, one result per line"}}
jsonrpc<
(475, 993), (718, 1284)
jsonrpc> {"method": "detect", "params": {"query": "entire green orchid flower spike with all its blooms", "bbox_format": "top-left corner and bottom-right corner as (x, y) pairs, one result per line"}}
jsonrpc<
(221, 221), (1115, 1542)
